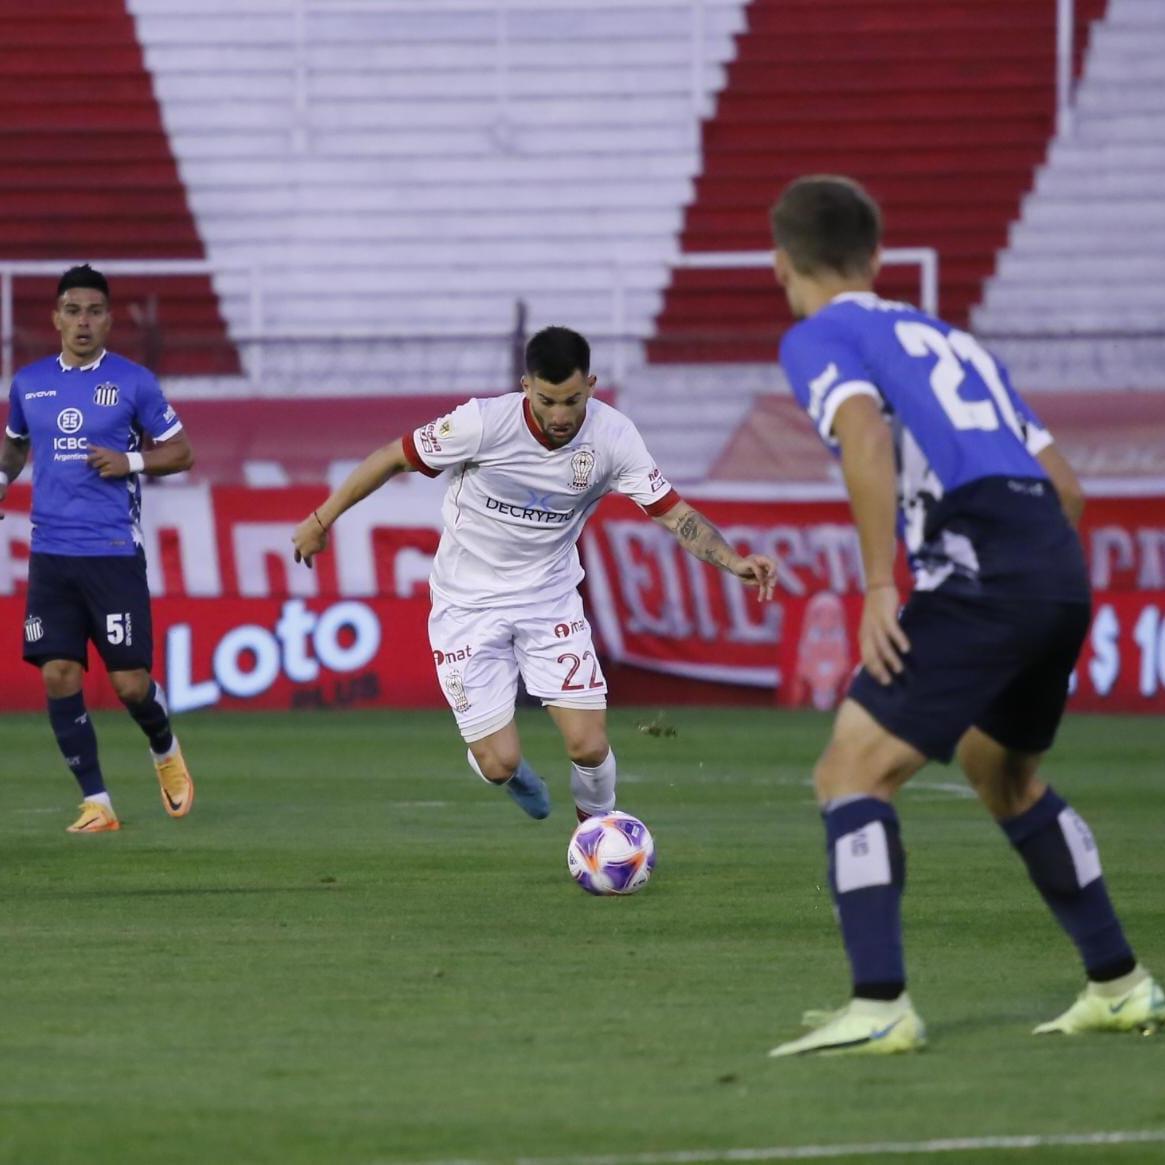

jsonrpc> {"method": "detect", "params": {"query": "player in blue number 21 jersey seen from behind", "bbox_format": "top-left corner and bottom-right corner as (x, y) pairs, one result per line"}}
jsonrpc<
(770, 177), (1165, 1055)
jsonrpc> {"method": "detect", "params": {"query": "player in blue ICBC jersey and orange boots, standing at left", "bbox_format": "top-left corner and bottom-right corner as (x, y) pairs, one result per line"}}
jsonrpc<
(0, 266), (195, 833)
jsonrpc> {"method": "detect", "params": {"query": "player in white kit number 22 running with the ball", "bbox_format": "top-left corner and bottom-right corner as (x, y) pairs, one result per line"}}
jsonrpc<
(294, 327), (774, 820)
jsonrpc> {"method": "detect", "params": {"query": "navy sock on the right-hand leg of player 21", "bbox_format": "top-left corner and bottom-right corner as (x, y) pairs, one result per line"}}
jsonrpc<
(1000, 788), (1136, 982)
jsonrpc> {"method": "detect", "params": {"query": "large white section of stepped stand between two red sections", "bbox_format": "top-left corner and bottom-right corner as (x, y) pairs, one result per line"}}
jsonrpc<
(122, 0), (747, 394)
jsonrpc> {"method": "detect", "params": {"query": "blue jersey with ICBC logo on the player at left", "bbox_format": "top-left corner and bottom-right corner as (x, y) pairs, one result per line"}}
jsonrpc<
(7, 352), (182, 556)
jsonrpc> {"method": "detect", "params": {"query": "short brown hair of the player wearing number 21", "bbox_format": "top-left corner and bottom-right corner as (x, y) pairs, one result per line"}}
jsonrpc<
(769, 174), (882, 275)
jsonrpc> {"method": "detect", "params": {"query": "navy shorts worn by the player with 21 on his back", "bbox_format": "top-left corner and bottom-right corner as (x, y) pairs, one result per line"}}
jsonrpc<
(849, 592), (1092, 763)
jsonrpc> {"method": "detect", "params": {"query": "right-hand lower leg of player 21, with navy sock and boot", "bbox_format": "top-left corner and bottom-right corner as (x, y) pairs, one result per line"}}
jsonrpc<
(956, 728), (1165, 1036)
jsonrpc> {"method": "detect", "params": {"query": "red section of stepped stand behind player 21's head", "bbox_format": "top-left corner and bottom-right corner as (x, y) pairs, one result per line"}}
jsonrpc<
(649, 0), (1104, 362)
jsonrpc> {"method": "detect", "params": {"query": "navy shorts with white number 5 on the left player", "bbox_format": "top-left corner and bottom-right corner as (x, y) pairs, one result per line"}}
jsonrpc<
(24, 551), (154, 671)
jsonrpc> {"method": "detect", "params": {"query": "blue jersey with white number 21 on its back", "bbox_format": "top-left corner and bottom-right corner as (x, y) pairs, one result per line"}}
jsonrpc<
(781, 292), (1087, 599)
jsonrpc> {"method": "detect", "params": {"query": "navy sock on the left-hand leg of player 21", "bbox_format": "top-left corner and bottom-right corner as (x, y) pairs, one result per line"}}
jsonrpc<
(822, 797), (906, 1000)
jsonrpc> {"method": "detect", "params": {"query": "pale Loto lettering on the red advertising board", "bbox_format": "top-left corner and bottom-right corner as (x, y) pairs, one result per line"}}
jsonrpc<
(165, 599), (381, 712)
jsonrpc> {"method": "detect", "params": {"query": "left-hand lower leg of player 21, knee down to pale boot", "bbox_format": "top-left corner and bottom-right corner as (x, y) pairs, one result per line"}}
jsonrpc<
(769, 700), (926, 1057)
